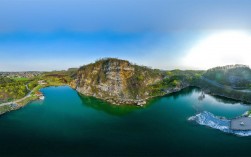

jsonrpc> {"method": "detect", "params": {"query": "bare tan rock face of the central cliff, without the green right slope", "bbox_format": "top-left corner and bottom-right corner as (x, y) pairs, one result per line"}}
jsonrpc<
(71, 58), (163, 106)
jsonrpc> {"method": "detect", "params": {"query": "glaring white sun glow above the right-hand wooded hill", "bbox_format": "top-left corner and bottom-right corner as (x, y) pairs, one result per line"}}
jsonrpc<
(182, 31), (251, 69)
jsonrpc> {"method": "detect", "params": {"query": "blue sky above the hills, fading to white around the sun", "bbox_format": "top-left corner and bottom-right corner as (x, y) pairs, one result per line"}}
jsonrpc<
(0, 0), (251, 71)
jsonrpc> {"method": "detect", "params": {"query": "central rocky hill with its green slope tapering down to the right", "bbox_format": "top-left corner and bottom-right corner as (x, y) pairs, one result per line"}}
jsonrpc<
(71, 58), (202, 106)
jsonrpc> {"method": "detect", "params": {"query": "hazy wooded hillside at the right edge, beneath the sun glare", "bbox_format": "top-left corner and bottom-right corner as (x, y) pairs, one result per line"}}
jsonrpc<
(196, 65), (251, 103)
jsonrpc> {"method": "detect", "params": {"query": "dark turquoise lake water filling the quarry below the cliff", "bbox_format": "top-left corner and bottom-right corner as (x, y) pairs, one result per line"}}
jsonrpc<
(0, 86), (251, 157)
